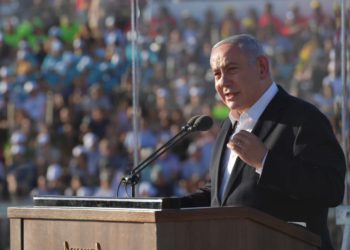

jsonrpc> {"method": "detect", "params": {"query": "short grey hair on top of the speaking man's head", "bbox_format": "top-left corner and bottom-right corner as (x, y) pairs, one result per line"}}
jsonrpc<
(213, 34), (266, 63)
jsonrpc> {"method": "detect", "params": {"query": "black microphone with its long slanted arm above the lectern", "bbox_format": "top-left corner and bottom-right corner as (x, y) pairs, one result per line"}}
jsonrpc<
(121, 115), (213, 197)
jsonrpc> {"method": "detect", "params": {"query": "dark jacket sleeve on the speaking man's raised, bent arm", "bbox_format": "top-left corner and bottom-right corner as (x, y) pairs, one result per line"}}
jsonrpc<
(258, 108), (346, 207)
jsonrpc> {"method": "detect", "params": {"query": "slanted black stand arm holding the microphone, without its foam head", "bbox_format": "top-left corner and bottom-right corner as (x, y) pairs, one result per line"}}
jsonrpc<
(122, 124), (193, 198)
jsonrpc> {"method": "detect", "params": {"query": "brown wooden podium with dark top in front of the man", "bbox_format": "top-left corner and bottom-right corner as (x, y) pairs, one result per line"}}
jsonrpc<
(8, 198), (321, 250)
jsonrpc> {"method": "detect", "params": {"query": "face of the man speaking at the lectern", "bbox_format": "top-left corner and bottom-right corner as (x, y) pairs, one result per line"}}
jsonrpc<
(210, 44), (264, 113)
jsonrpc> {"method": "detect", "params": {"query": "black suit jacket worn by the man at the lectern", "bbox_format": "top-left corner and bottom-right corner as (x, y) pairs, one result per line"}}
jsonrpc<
(182, 87), (346, 249)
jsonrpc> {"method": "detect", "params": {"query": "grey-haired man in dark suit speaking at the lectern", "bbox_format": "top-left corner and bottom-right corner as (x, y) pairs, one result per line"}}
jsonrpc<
(182, 34), (346, 249)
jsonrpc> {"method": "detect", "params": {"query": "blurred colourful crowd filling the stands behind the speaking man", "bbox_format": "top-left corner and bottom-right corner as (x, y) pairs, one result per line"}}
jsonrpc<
(0, 0), (350, 201)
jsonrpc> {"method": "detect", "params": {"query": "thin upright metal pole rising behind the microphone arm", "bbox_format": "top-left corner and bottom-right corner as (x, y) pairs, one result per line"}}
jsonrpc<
(131, 0), (140, 197)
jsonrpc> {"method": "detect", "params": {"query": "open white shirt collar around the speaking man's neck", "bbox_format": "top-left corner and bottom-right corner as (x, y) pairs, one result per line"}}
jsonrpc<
(229, 82), (278, 129)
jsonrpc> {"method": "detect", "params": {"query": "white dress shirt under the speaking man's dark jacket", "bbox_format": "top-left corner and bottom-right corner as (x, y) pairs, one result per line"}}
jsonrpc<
(219, 82), (278, 200)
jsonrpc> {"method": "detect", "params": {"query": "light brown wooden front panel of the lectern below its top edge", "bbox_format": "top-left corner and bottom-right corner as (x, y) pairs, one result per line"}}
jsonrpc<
(23, 220), (156, 250)
